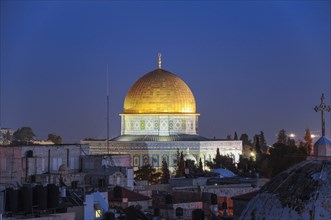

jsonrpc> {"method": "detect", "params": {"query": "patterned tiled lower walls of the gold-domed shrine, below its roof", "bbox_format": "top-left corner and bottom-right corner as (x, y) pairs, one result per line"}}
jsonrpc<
(84, 141), (242, 169)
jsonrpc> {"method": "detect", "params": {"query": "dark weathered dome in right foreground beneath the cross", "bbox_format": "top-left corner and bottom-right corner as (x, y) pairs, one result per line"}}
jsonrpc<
(240, 160), (331, 219)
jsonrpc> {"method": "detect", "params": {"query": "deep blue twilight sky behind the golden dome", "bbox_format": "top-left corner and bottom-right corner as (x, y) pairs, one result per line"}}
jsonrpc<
(0, 0), (331, 144)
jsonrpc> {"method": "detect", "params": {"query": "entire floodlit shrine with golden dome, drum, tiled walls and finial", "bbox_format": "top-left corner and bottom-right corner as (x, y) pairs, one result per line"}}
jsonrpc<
(82, 56), (242, 168)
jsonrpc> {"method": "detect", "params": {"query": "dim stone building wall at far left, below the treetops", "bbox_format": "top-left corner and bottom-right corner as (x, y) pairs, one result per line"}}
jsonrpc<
(0, 145), (89, 183)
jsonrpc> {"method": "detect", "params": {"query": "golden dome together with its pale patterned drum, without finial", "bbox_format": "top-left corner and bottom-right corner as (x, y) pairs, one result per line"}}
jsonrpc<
(121, 69), (199, 136)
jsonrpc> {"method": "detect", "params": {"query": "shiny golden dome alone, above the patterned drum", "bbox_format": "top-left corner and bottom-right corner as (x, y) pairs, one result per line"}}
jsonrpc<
(124, 69), (196, 114)
